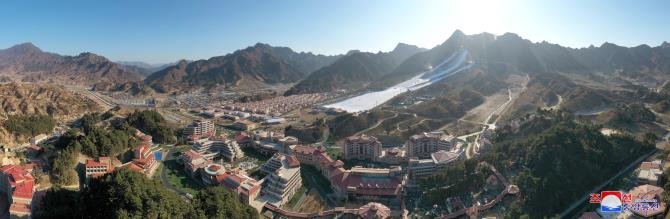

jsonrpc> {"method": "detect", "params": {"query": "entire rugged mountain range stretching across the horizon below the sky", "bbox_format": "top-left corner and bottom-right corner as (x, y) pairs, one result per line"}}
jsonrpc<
(0, 31), (670, 98)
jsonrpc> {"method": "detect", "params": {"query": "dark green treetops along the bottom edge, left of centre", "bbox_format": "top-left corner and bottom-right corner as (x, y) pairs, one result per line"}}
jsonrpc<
(34, 169), (259, 219)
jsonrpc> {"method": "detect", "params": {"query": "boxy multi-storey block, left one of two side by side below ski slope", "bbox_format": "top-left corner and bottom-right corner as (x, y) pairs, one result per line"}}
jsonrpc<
(344, 134), (382, 160)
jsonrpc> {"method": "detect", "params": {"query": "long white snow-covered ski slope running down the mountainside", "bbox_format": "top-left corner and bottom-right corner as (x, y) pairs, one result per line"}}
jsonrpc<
(325, 50), (473, 112)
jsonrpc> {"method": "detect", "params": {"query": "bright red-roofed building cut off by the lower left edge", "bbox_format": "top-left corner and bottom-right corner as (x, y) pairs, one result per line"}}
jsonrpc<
(0, 164), (35, 218)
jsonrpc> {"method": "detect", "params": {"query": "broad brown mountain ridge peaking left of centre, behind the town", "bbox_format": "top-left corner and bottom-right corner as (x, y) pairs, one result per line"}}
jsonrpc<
(144, 43), (339, 92)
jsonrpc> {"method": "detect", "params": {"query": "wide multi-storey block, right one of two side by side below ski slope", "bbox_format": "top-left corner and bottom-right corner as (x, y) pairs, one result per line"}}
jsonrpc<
(406, 131), (456, 159)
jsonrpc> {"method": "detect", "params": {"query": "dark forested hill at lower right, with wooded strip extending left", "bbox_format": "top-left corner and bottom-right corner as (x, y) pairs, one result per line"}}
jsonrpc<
(421, 112), (654, 218)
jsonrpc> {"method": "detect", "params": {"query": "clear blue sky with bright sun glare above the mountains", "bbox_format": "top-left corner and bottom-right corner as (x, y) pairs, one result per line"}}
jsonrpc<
(0, 0), (670, 63)
